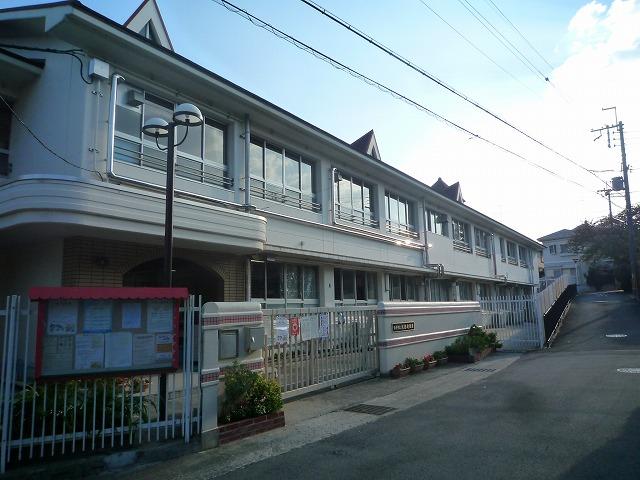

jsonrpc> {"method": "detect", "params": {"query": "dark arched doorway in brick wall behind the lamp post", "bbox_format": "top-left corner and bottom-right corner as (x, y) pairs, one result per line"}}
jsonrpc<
(122, 258), (224, 303)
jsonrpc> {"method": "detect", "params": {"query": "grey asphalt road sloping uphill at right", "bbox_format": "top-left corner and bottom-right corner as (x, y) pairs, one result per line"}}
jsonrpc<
(223, 293), (640, 480)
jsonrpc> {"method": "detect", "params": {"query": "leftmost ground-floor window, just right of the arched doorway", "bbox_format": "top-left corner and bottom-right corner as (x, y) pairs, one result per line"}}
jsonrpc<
(251, 261), (320, 308)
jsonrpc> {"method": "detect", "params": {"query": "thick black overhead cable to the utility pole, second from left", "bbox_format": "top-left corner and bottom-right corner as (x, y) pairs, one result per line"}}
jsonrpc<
(298, 0), (609, 190)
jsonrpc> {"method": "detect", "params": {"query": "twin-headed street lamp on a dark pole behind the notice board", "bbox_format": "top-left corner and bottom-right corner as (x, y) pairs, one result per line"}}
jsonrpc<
(142, 103), (204, 287)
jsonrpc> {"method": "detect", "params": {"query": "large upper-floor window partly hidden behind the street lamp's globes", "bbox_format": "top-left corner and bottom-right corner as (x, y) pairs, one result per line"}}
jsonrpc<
(114, 83), (233, 188)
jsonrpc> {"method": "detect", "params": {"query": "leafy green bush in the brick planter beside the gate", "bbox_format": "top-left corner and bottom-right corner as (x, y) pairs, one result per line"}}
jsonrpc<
(220, 362), (282, 423)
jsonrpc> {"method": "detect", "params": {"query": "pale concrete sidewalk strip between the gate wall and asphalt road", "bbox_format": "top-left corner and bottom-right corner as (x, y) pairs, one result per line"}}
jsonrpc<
(112, 353), (521, 480)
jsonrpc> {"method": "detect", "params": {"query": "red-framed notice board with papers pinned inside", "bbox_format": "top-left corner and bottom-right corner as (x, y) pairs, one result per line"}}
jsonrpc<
(29, 287), (189, 378)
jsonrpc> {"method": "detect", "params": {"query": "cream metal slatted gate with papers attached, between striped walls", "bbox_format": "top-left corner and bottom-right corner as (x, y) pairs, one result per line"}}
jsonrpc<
(263, 306), (378, 397)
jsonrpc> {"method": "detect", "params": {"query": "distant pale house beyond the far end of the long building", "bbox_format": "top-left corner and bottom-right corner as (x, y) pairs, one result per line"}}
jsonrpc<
(538, 228), (591, 292)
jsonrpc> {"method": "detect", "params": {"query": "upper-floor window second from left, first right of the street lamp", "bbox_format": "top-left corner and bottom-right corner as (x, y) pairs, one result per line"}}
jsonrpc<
(249, 136), (320, 212)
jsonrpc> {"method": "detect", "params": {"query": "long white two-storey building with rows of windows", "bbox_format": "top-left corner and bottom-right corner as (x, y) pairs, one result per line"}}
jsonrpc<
(0, 1), (541, 307)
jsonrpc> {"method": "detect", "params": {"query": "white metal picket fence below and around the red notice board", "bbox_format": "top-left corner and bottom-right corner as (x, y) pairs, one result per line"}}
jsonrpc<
(0, 295), (201, 472)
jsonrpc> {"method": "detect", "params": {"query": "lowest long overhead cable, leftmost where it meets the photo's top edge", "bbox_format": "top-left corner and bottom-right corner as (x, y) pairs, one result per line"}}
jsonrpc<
(211, 0), (620, 199)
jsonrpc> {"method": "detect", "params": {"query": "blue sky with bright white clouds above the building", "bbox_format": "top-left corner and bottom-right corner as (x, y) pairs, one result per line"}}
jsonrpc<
(5, 0), (640, 238)
